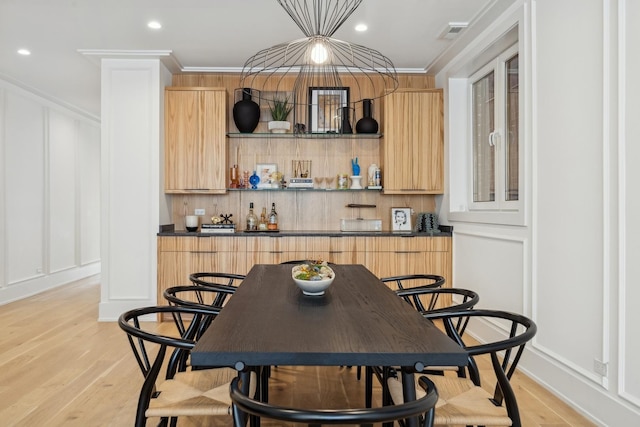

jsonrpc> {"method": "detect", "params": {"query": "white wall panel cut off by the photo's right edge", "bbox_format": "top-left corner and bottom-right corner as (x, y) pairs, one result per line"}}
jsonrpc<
(617, 0), (640, 407)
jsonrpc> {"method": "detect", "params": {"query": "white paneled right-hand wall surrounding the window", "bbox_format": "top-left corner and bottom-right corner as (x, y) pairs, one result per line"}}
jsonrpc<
(437, 0), (640, 426)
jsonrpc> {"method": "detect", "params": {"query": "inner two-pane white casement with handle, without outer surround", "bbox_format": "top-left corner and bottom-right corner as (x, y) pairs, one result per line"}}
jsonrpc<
(468, 46), (521, 211)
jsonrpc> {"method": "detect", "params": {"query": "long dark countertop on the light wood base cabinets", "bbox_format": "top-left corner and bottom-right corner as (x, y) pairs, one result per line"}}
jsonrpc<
(158, 225), (453, 237)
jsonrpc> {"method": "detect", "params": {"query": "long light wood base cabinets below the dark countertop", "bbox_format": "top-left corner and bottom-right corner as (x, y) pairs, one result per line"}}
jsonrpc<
(158, 235), (452, 304)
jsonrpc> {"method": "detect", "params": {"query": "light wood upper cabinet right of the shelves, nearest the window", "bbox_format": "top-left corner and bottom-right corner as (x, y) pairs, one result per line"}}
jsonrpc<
(381, 89), (444, 194)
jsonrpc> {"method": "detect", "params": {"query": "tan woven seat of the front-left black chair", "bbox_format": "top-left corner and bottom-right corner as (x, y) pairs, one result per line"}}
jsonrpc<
(145, 368), (256, 417)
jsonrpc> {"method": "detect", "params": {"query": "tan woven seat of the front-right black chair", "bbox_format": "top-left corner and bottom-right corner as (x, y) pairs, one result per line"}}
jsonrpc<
(388, 375), (512, 426)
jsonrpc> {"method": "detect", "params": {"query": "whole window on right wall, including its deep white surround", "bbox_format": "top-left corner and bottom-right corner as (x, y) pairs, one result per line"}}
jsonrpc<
(444, 19), (532, 226)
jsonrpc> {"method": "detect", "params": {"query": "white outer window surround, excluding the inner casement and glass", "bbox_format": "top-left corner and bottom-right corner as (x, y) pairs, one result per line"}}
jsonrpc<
(444, 22), (524, 226)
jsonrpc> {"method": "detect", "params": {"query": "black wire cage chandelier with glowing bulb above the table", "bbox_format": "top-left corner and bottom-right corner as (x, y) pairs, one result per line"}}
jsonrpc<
(240, 0), (398, 134)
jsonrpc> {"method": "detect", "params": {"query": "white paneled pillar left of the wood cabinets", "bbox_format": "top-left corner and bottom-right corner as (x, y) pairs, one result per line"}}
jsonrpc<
(99, 59), (171, 320)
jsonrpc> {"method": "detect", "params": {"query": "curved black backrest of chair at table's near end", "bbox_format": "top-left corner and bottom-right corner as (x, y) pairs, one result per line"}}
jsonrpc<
(230, 377), (438, 427)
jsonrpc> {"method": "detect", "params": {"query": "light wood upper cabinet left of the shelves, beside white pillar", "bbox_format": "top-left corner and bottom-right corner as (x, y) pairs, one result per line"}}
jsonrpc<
(164, 87), (227, 194)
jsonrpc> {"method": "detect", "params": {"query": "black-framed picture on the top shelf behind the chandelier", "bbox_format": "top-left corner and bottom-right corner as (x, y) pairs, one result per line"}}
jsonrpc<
(309, 87), (349, 133)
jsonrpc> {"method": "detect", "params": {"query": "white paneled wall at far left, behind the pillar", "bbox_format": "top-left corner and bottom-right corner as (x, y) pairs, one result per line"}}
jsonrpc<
(0, 80), (100, 304)
